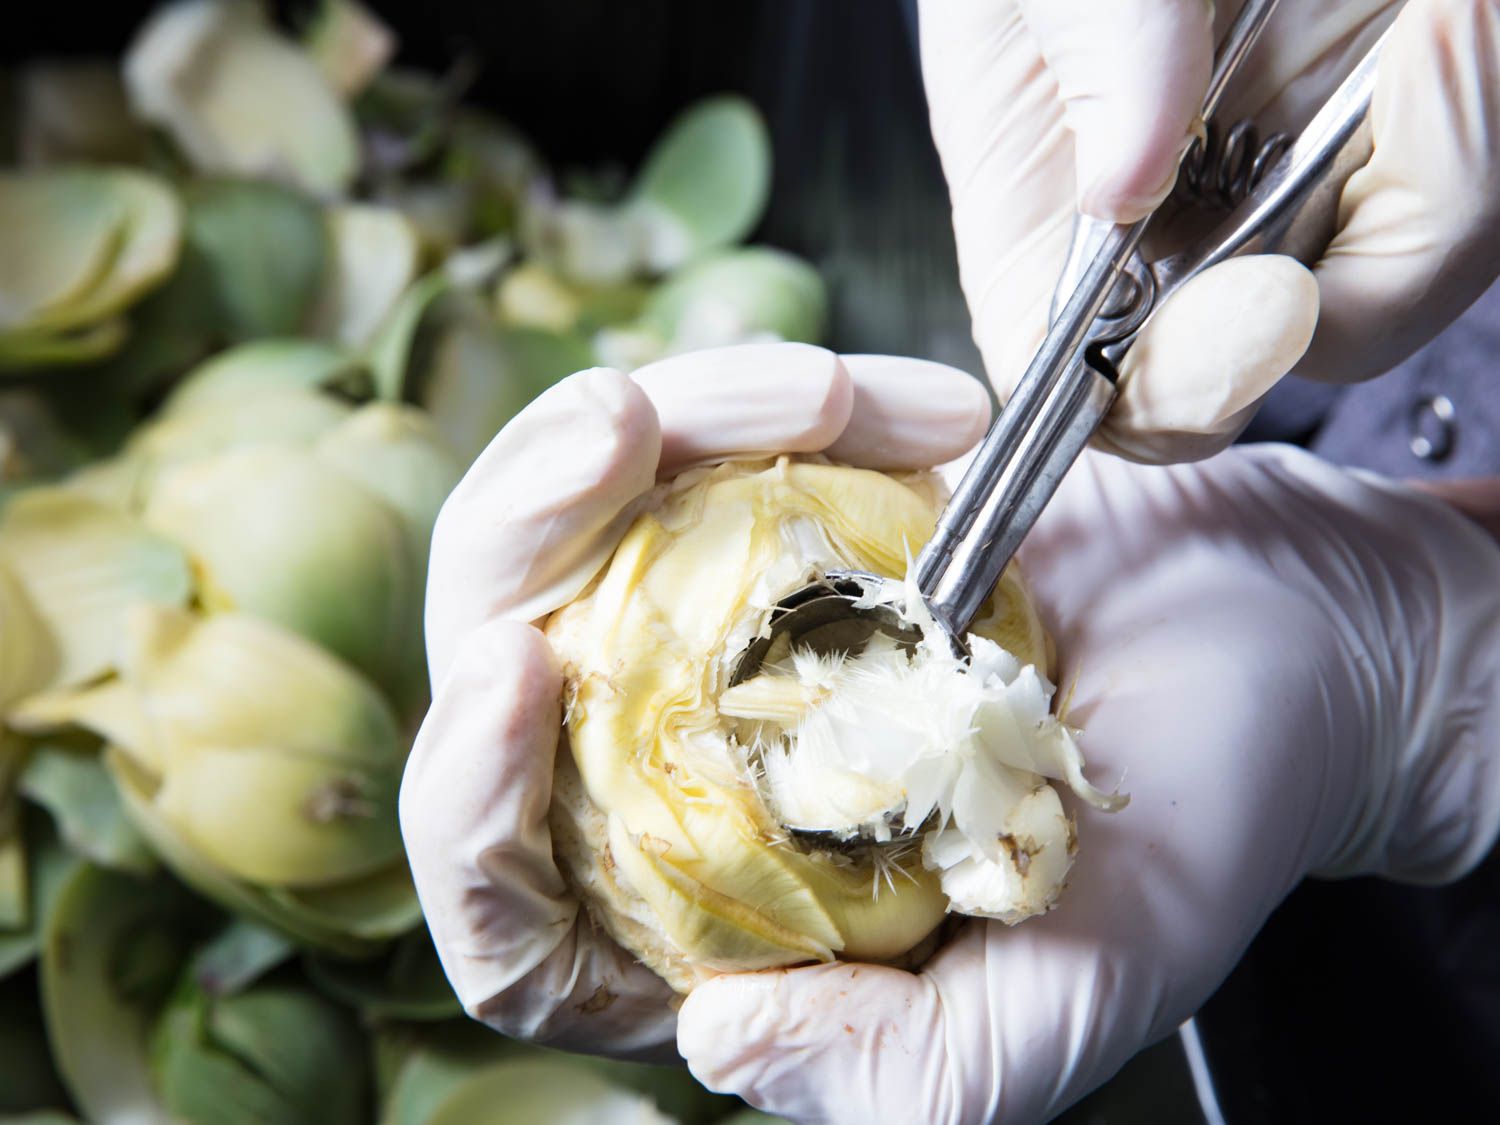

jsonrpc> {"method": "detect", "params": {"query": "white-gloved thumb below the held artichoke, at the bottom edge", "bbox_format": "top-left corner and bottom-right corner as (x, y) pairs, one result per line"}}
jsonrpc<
(677, 965), (954, 1125)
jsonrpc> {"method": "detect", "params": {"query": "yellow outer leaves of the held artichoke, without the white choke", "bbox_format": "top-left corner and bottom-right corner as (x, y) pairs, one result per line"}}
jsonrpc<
(546, 458), (1098, 990)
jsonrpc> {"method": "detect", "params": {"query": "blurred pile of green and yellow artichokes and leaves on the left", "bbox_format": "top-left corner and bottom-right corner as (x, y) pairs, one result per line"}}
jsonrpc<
(0, 0), (825, 1125)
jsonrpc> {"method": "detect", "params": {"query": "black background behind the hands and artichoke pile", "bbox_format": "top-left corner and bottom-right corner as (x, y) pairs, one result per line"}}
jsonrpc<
(11, 0), (1500, 1125)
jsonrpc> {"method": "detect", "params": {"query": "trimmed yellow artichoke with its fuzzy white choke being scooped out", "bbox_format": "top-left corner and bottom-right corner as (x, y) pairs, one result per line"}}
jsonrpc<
(546, 458), (1112, 992)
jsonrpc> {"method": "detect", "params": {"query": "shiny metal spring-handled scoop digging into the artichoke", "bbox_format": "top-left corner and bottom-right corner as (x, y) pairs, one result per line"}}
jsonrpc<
(744, 0), (1385, 833)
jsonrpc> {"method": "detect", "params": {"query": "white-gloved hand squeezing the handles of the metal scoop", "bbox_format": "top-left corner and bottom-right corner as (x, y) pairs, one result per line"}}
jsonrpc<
(920, 0), (1500, 461)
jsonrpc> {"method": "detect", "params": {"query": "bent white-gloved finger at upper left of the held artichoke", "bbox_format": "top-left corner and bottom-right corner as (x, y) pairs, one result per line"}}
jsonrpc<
(426, 368), (662, 687)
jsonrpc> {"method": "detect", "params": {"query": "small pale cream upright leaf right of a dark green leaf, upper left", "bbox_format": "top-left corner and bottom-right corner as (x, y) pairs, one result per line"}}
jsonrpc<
(309, 204), (422, 347)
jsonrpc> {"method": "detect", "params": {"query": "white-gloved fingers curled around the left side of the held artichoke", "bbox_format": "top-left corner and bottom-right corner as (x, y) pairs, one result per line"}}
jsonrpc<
(401, 344), (989, 1058)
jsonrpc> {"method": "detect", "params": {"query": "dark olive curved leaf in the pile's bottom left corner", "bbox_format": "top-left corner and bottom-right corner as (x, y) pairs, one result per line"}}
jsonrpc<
(41, 864), (180, 1122)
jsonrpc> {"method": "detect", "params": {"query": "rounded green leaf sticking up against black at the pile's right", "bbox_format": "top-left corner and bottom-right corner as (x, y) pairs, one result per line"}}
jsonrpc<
(632, 96), (771, 273)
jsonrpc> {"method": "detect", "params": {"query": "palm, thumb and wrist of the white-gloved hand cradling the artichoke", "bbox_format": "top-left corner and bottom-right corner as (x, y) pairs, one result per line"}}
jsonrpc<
(678, 446), (1500, 1122)
